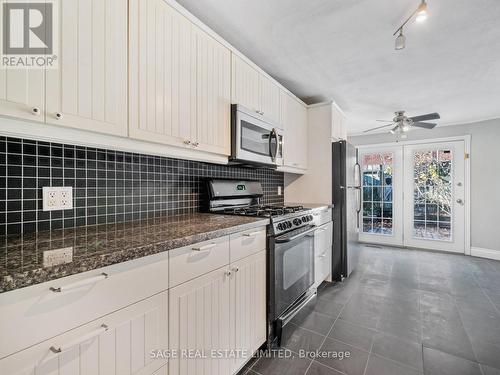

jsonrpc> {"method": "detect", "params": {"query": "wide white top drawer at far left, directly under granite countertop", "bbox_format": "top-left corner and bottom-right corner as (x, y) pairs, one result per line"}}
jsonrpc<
(0, 253), (168, 360)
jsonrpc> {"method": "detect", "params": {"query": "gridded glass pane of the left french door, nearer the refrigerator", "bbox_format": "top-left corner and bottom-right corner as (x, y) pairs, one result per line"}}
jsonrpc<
(361, 152), (394, 236)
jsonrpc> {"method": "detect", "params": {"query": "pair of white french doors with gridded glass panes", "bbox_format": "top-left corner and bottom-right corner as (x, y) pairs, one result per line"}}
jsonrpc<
(359, 141), (465, 253)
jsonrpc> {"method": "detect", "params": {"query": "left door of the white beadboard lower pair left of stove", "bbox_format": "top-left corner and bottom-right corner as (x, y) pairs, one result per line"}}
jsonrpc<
(169, 267), (231, 375)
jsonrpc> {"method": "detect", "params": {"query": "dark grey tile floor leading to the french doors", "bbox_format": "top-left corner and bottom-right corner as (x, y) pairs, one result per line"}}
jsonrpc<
(242, 247), (500, 375)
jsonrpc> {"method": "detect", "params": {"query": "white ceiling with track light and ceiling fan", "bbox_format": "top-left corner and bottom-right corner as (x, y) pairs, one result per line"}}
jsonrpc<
(178, 0), (500, 133)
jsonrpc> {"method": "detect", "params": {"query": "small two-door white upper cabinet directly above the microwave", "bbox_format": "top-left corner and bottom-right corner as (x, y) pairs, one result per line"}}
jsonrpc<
(231, 53), (281, 125)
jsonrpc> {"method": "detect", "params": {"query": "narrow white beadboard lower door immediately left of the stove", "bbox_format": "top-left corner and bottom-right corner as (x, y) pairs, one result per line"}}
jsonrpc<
(230, 251), (266, 373)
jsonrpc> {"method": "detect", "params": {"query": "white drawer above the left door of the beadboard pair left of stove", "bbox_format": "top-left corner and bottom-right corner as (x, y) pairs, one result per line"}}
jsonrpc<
(168, 236), (229, 288)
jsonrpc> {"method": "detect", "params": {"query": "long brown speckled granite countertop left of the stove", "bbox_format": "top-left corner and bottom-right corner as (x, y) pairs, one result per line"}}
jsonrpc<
(0, 213), (269, 293)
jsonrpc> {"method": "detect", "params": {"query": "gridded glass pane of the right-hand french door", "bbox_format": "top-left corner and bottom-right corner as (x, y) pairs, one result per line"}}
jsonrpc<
(413, 149), (453, 241)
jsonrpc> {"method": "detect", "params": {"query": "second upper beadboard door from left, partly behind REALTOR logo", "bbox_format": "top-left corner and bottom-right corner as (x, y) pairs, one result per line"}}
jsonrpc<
(45, 0), (128, 136)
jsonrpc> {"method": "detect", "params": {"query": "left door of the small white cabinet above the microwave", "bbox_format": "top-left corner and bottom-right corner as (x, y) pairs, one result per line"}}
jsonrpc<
(231, 53), (260, 112)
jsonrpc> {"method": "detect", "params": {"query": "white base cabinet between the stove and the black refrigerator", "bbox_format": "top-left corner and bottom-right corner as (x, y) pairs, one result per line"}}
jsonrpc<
(314, 221), (333, 287)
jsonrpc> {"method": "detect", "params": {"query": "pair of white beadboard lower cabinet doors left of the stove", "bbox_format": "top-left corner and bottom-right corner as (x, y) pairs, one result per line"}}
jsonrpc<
(169, 251), (266, 375)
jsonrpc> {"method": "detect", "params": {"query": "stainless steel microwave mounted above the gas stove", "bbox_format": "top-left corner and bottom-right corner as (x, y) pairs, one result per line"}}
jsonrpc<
(230, 104), (283, 168)
